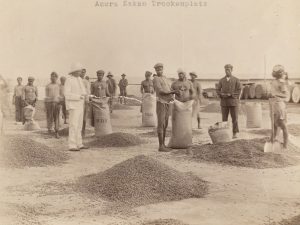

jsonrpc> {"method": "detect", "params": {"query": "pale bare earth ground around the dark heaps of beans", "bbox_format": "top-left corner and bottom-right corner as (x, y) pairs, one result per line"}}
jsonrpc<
(0, 100), (300, 225)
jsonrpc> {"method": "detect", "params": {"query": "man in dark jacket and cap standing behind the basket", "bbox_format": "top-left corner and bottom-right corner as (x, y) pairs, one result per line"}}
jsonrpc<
(217, 64), (242, 138)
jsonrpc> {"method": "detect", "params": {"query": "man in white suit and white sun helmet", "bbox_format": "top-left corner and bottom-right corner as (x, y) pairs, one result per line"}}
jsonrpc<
(65, 63), (88, 151)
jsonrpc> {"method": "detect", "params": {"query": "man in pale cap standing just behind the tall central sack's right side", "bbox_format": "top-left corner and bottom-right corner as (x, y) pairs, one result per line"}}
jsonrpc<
(190, 72), (202, 129)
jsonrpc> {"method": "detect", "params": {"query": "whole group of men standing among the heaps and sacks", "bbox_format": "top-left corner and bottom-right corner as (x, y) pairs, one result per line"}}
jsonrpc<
(3, 63), (288, 152)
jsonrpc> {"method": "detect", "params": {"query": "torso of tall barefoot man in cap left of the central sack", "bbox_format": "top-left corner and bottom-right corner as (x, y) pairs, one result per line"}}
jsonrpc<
(153, 76), (172, 103)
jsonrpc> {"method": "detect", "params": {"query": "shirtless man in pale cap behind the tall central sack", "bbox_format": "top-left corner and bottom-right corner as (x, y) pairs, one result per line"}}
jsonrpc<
(171, 70), (194, 102)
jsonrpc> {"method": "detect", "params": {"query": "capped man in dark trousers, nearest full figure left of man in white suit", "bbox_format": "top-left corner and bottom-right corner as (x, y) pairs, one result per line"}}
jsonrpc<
(45, 72), (62, 138)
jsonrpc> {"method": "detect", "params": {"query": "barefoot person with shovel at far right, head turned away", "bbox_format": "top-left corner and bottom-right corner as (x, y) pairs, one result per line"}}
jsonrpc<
(270, 65), (289, 149)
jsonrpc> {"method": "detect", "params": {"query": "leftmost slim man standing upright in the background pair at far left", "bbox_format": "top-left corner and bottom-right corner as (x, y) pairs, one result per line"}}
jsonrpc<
(13, 77), (24, 123)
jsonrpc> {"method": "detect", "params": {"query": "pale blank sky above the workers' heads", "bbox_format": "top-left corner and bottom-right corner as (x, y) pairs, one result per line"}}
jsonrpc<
(0, 0), (300, 80)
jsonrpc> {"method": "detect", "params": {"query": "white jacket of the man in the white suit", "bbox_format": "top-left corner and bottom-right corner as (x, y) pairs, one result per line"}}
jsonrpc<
(65, 76), (87, 109)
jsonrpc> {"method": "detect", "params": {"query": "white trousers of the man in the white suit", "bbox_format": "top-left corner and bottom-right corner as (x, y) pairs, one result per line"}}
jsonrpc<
(68, 101), (84, 148)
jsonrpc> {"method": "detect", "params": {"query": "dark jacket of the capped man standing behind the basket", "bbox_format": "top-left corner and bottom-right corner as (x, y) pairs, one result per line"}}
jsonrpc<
(217, 76), (242, 106)
